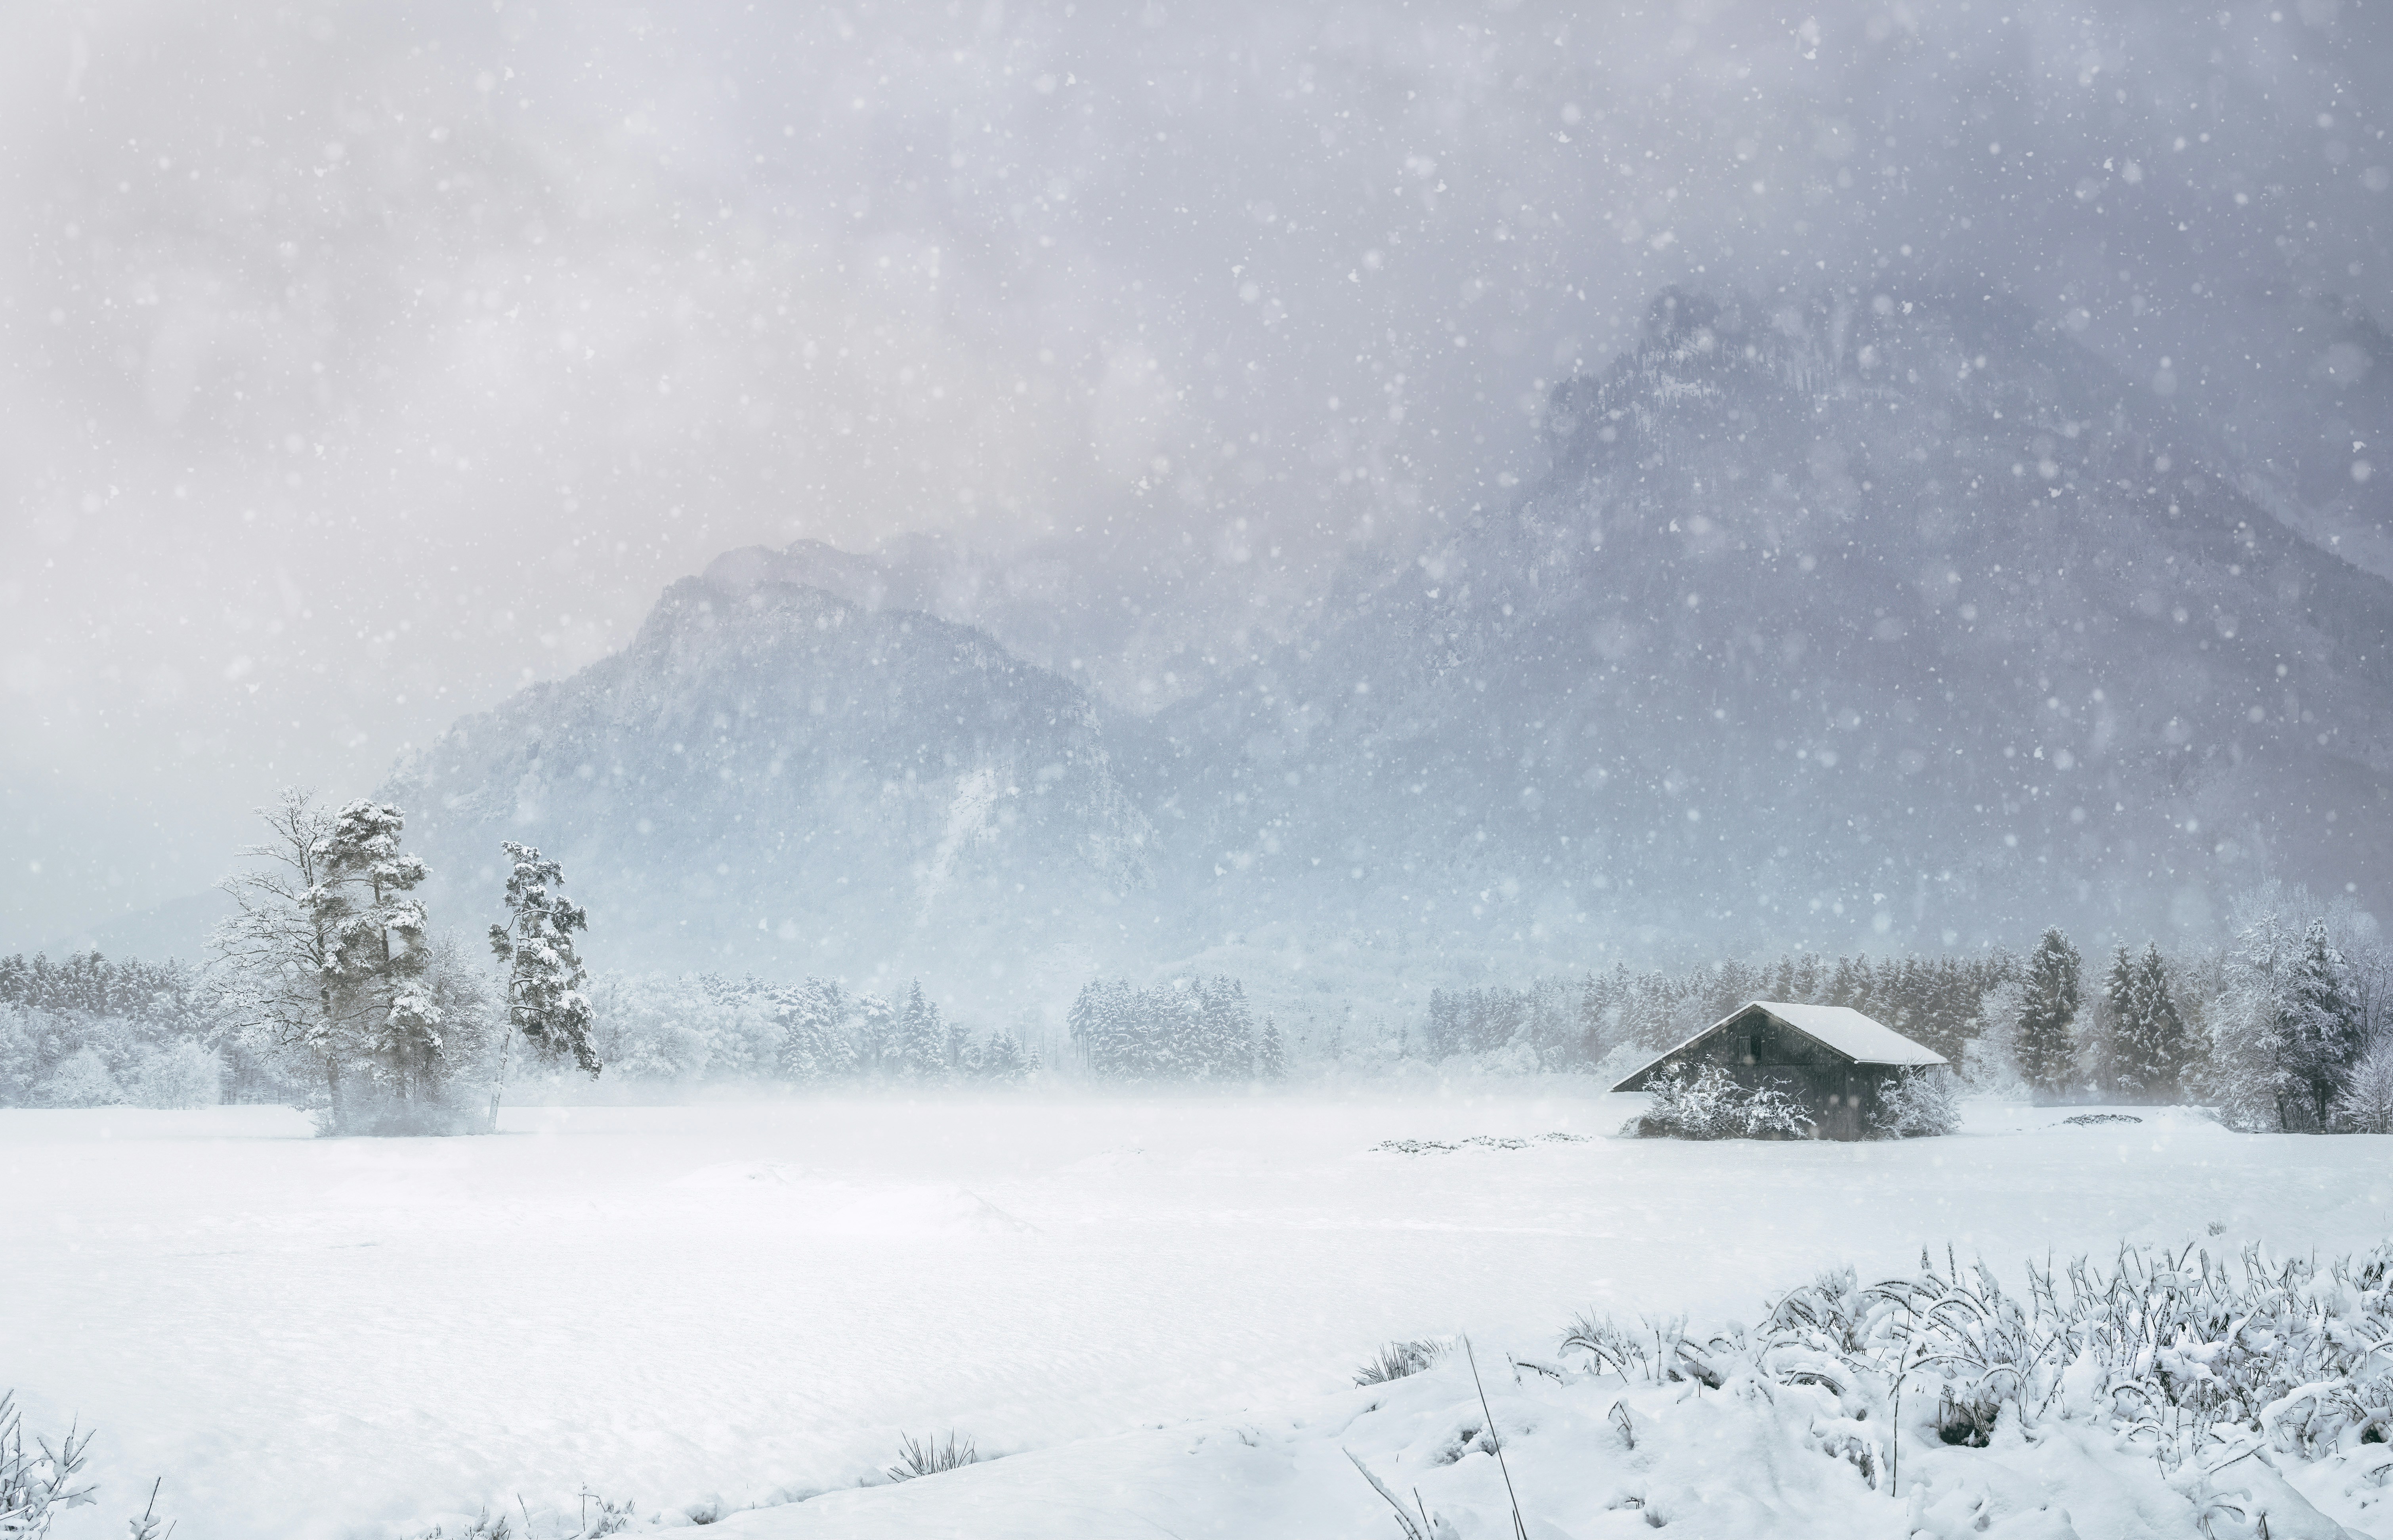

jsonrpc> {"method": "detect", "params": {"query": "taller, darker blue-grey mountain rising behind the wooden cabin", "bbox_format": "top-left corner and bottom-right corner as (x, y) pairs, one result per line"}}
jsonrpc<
(1168, 294), (2393, 956)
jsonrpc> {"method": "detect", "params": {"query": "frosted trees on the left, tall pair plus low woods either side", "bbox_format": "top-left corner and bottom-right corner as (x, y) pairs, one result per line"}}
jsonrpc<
(0, 792), (1039, 1114)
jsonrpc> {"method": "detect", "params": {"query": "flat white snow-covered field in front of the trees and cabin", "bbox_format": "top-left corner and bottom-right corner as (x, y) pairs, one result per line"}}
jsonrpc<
(0, 1093), (2393, 1540)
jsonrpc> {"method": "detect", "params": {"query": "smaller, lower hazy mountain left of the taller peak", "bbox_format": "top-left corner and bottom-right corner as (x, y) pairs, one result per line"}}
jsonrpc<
(385, 579), (1149, 994)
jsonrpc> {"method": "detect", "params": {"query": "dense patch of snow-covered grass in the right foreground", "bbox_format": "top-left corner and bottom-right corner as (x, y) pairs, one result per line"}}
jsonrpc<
(1562, 1244), (2393, 1473)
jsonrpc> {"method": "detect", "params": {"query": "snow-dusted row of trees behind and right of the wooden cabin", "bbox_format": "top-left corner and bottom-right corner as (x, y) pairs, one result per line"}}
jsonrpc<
(1419, 882), (2393, 1131)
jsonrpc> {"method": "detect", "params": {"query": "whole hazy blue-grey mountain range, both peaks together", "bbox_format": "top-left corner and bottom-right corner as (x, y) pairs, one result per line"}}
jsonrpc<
(373, 292), (2393, 1002)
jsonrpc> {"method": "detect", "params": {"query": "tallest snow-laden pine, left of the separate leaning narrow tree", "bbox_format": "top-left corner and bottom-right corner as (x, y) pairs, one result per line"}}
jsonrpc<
(325, 801), (447, 1131)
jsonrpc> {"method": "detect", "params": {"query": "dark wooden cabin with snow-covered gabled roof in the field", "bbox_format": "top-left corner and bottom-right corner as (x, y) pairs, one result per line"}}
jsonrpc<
(1613, 1000), (1950, 1138)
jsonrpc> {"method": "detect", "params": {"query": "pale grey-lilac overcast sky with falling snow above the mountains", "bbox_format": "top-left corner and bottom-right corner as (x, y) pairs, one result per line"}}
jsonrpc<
(0, 0), (2393, 947)
